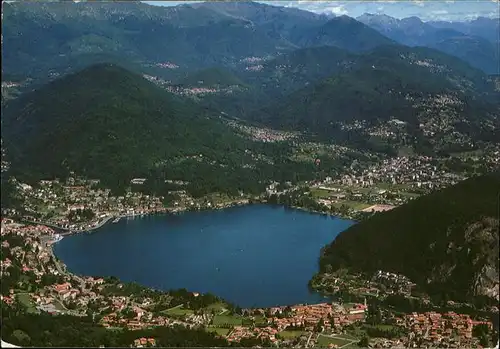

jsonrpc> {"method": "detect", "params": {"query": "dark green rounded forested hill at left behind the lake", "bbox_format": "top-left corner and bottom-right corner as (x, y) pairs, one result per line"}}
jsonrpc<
(2, 64), (320, 195)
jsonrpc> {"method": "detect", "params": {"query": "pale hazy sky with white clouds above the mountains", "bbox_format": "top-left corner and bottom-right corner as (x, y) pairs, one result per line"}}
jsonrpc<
(145, 0), (500, 21)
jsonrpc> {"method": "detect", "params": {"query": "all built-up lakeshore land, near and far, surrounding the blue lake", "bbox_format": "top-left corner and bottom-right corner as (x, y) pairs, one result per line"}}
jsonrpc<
(1, 143), (499, 348)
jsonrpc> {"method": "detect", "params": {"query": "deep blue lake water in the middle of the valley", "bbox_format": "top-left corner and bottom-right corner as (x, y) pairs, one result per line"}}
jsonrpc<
(54, 204), (354, 307)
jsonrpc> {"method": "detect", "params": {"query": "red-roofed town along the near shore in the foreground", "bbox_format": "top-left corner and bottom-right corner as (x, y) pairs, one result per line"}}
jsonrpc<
(1, 218), (498, 348)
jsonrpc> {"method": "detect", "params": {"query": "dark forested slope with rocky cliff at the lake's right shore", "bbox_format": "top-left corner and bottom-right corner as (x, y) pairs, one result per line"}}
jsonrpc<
(320, 173), (500, 300)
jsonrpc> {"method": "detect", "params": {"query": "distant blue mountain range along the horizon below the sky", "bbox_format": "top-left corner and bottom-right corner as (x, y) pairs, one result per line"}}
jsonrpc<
(2, 1), (498, 79)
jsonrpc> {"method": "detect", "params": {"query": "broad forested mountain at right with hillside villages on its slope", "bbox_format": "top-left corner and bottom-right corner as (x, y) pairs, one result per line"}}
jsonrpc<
(253, 46), (500, 154)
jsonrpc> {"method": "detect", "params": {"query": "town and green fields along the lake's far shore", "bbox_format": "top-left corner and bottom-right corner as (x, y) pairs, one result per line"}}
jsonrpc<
(2, 143), (500, 234)
